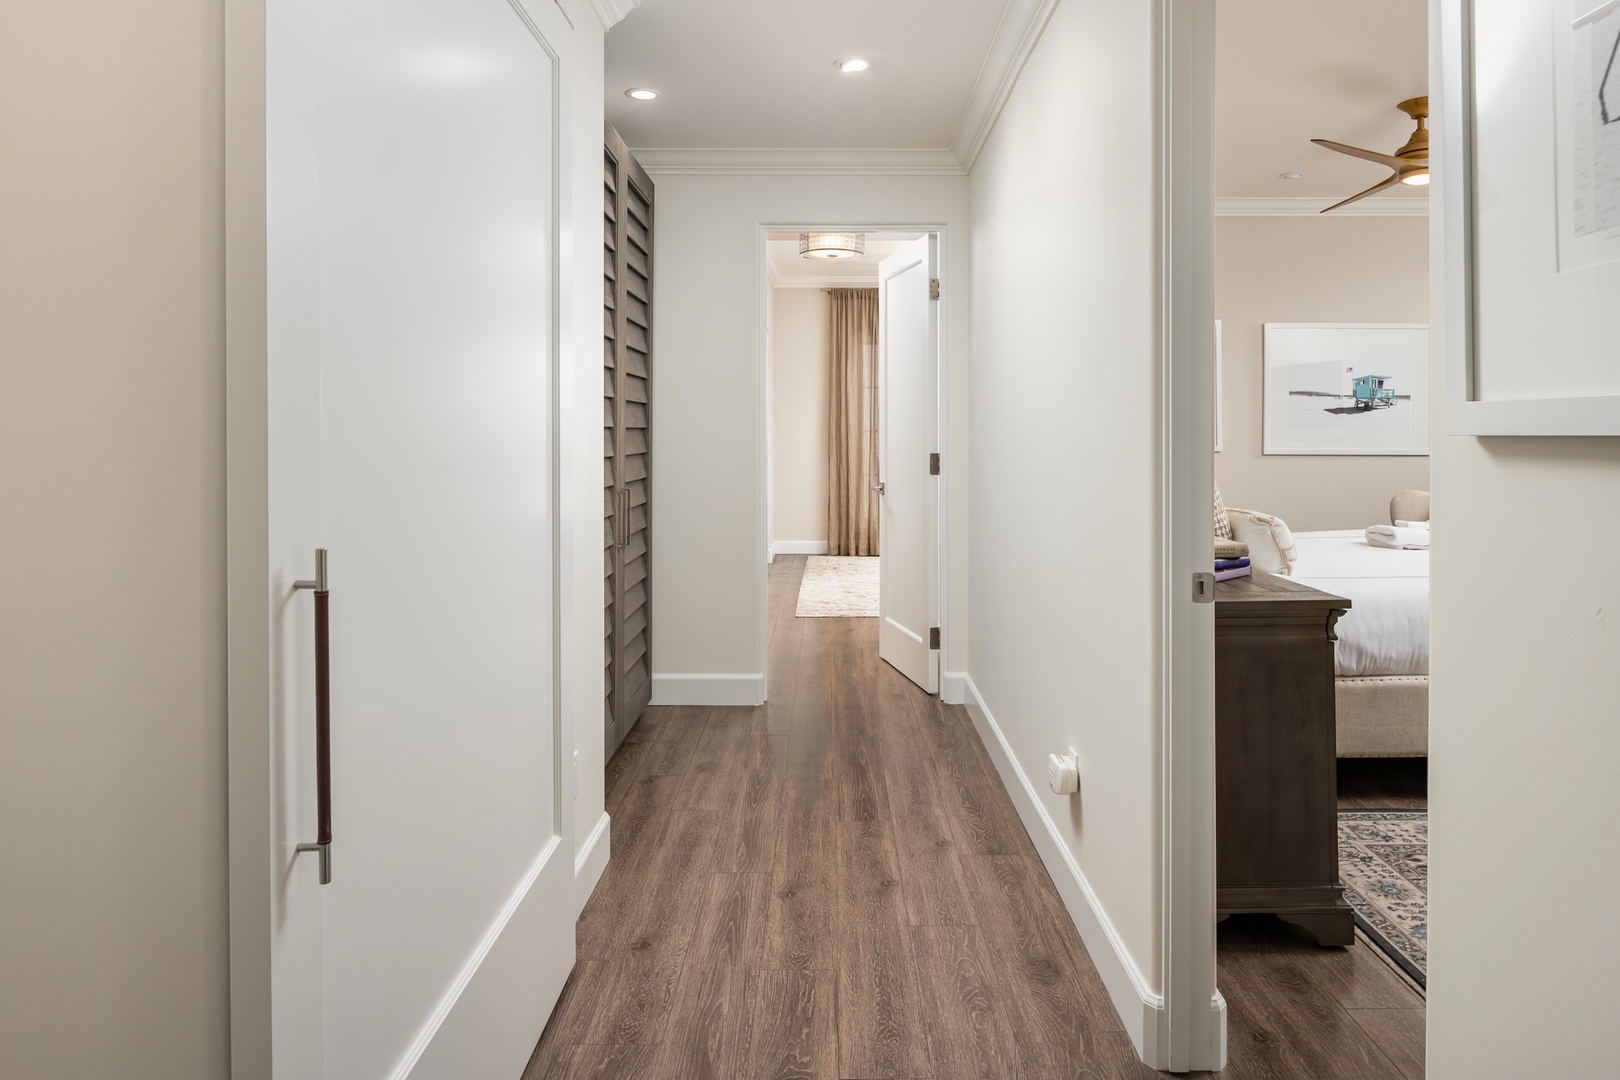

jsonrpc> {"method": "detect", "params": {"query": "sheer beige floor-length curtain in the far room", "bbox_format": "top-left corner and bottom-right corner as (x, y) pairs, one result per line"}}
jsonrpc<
(826, 288), (878, 555)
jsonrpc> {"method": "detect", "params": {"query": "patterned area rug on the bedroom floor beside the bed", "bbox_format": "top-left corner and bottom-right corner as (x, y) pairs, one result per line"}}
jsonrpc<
(1338, 810), (1429, 988)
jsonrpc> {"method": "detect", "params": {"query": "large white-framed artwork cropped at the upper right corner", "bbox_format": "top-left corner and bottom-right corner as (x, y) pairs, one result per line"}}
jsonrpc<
(1435, 0), (1620, 436)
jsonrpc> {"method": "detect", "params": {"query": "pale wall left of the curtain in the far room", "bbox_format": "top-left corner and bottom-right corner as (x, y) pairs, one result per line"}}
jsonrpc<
(771, 288), (829, 554)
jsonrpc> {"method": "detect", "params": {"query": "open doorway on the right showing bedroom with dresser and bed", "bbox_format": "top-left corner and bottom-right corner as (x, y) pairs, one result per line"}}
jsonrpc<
(1171, 0), (1429, 1077)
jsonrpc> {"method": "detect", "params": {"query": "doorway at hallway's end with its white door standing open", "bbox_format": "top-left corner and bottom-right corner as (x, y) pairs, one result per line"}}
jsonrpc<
(761, 225), (944, 696)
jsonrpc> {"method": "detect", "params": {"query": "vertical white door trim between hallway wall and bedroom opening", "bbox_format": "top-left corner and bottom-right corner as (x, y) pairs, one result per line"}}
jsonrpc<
(1159, 0), (1226, 1072)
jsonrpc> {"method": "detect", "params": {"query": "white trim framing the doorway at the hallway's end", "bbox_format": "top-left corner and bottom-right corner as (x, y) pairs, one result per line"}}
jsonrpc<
(753, 222), (946, 705)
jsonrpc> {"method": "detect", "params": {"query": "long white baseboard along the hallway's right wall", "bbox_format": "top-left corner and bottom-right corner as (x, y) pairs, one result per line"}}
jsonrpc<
(961, 675), (1168, 1069)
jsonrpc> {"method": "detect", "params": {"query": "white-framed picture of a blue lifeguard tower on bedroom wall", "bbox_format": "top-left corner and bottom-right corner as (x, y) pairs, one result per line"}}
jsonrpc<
(1262, 322), (1429, 455)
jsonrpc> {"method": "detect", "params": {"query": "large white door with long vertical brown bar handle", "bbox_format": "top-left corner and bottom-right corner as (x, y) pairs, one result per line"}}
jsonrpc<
(249, 0), (573, 1080)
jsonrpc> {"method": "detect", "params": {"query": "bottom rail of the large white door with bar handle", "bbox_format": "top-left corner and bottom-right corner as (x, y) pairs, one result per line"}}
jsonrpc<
(389, 837), (573, 1080)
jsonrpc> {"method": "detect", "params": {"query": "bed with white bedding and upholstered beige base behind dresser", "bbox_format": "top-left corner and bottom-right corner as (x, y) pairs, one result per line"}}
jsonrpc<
(1291, 529), (1429, 758)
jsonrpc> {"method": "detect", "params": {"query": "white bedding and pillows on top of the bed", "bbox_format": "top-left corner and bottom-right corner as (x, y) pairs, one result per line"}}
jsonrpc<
(1293, 529), (1443, 675)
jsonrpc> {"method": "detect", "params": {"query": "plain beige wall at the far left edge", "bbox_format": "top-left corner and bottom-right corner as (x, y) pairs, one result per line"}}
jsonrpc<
(0, 0), (228, 1080)
